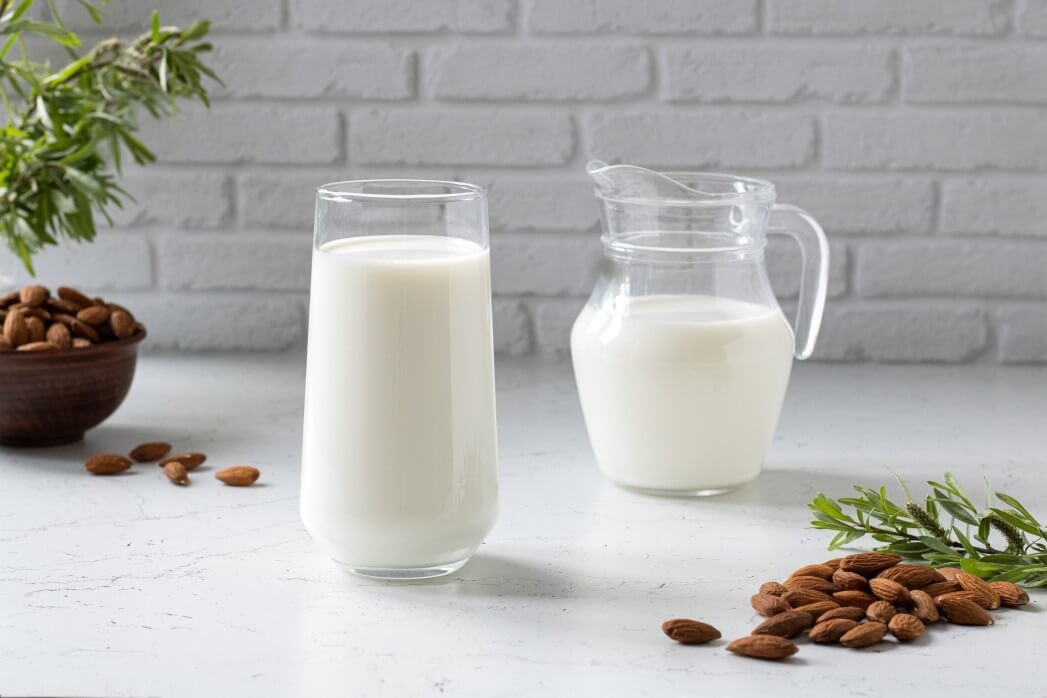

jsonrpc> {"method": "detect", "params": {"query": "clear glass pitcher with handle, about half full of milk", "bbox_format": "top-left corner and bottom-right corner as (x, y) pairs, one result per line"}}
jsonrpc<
(571, 161), (829, 496)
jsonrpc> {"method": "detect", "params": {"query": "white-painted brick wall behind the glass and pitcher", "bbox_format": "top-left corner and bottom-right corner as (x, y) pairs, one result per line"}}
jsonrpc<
(0, 0), (1047, 363)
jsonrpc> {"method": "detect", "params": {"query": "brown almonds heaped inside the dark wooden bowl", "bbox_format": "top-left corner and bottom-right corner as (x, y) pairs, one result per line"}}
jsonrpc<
(0, 286), (146, 352)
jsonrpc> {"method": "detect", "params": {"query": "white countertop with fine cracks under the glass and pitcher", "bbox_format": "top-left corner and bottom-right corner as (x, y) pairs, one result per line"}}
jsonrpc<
(0, 356), (1047, 698)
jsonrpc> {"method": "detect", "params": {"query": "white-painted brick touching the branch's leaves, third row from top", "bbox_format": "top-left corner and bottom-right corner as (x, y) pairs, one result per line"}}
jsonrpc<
(141, 105), (341, 163)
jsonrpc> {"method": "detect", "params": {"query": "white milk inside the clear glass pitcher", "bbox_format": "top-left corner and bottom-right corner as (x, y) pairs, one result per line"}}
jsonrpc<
(571, 295), (793, 493)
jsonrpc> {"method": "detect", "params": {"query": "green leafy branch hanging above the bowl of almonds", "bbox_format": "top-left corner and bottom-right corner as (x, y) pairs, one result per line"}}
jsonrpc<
(0, 0), (218, 274)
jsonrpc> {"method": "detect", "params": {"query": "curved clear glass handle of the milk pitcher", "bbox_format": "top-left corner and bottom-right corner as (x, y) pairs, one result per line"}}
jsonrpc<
(767, 204), (829, 359)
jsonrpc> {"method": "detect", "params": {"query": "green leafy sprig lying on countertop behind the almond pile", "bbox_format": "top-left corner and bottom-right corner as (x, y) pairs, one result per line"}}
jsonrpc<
(807, 473), (1047, 587)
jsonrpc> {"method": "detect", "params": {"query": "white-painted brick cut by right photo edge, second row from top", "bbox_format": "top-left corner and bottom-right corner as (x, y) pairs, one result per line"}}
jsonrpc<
(904, 45), (1047, 105)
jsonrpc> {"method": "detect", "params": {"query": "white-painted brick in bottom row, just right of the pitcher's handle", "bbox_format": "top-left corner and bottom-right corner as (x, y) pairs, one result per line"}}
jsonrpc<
(814, 303), (988, 362)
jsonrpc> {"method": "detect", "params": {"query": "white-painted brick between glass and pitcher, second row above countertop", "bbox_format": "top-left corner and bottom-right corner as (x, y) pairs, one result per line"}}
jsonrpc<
(491, 234), (603, 295)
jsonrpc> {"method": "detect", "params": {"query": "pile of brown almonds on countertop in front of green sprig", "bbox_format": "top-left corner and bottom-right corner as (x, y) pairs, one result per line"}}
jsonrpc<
(662, 553), (1029, 659)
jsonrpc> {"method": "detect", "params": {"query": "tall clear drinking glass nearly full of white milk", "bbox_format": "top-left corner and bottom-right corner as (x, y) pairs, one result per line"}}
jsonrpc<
(300, 180), (497, 579)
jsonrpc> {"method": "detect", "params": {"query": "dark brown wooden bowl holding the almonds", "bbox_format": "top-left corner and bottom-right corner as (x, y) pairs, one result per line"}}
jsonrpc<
(0, 331), (146, 446)
